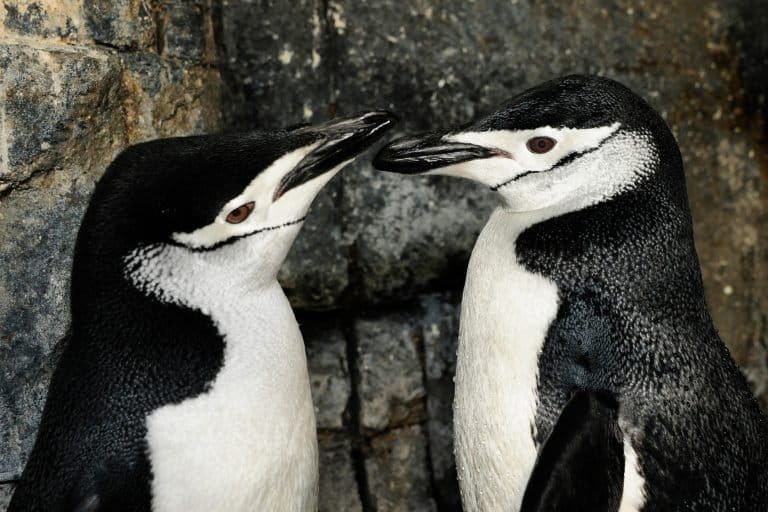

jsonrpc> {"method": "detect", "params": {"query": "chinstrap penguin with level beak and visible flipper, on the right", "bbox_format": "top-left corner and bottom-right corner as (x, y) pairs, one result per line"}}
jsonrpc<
(374, 76), (768, 512)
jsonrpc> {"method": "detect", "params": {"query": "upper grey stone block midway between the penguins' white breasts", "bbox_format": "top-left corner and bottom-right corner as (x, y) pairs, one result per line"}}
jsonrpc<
(355, 313), (425, 431)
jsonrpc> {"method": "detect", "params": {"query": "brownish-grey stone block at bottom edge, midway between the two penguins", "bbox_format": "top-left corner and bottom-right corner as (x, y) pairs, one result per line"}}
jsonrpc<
(365, 426), (437, 512)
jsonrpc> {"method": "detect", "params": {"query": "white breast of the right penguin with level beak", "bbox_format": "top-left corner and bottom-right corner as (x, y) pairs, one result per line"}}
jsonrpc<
(454, 209), (558, 512)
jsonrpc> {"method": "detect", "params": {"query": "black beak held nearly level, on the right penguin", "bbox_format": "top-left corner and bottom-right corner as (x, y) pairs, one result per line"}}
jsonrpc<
(373, 133), (500, 174)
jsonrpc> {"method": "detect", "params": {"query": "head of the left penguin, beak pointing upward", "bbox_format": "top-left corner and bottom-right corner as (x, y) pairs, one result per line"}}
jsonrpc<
(82, 112), (394, 296)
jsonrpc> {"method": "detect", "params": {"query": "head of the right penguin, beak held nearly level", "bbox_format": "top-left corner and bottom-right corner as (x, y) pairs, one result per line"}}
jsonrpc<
(374, 75), (679, 212)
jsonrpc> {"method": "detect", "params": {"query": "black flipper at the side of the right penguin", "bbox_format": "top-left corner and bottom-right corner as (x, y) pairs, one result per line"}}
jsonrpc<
(520, 391), (624, 512)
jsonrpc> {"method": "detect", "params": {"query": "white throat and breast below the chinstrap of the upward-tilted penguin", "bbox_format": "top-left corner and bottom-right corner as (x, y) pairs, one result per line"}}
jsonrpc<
(128, 236), (318, 512)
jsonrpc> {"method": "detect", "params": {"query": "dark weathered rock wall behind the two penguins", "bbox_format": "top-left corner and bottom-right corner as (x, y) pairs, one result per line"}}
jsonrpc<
(0, 0), (768, 511)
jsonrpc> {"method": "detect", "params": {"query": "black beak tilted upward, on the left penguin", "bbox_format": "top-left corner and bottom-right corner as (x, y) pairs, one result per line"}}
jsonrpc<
(272, 110), (397, 201)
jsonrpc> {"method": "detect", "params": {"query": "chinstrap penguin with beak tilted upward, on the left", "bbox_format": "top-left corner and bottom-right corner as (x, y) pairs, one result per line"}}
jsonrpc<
(9, 112), (394, 512)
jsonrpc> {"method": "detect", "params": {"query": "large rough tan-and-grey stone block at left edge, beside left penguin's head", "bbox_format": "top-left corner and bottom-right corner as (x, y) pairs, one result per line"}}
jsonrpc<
(0, 42), (126, 188)
